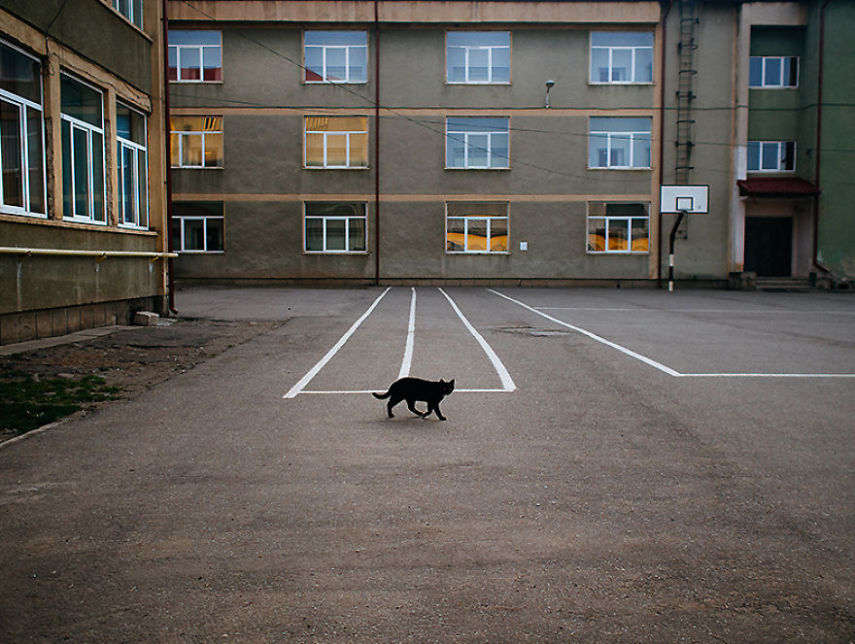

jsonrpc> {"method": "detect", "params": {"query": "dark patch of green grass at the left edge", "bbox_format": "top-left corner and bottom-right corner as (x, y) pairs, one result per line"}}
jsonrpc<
(0, 371), (120, 434)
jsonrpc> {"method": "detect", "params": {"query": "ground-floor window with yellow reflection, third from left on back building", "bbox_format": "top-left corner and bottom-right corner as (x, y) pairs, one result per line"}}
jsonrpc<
(445, 202), (508, 253)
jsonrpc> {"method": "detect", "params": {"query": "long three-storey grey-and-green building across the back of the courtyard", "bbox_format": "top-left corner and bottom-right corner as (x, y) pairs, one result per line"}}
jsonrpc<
(168, 0), (855, 286)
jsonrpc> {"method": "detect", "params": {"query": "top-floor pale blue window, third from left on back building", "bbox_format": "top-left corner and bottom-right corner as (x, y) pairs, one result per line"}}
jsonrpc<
(445, 31), (511, 84)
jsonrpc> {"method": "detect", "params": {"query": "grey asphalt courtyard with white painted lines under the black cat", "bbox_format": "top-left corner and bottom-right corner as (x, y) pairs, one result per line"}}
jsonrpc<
(0, 287), (855, 642)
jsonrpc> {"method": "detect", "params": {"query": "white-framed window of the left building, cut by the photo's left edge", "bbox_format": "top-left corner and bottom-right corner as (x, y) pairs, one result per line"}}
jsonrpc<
(0, 43), (46, 215)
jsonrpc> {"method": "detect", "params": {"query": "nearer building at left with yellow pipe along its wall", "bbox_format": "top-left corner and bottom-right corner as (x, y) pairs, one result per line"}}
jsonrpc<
(0, 0), (168, 344)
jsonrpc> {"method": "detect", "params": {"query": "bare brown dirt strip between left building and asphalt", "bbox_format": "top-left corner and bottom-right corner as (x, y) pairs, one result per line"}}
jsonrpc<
(0, 318), (281, 443)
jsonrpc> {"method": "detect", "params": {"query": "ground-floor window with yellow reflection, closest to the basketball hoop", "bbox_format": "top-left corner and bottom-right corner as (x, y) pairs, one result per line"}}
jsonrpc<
(588, 202), (650, 253)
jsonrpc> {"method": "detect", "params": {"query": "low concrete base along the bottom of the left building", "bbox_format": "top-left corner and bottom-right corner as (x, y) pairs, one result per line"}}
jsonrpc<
(0, 296), (168, 345)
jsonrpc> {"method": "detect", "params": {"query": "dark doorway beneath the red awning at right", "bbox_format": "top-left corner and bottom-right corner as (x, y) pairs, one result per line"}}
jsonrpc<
(745, 217), (793, 277)
